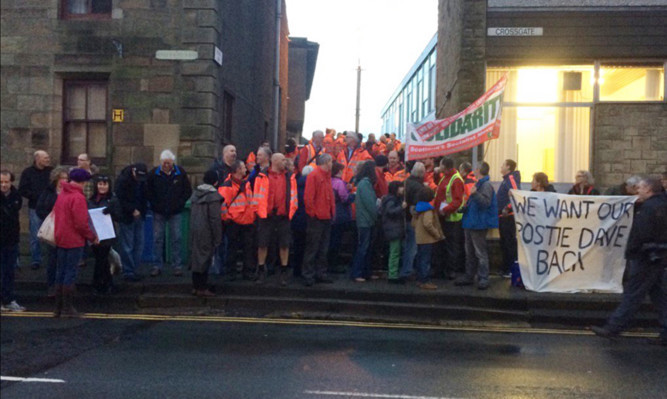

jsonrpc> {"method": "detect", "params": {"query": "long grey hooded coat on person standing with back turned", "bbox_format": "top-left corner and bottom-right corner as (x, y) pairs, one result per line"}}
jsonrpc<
(190, 184), (223, 273)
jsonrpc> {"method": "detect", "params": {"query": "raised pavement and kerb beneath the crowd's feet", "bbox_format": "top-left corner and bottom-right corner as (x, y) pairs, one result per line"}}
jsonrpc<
(15, 260), (658, 332)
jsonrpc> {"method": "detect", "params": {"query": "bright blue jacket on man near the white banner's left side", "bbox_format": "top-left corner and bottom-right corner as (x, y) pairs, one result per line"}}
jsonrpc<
(462, 176), (498, 230)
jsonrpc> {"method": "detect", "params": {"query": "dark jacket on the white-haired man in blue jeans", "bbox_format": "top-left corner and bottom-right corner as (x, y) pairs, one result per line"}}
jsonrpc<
(146, 165), (192, 216)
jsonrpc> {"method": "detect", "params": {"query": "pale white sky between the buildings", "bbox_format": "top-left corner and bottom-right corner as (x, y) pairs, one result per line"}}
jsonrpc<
(286, 0), (438, 139)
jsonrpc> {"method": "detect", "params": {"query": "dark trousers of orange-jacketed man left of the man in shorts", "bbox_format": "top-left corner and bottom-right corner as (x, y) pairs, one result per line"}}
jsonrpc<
(225, 223), (257, 275)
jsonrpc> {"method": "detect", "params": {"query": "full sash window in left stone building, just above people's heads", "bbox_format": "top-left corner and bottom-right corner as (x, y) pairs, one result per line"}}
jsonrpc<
(62, 81), (107, 165)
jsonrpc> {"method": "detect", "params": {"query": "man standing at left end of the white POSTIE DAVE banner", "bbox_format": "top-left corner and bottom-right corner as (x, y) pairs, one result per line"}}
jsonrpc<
(496, 159), (521, 278)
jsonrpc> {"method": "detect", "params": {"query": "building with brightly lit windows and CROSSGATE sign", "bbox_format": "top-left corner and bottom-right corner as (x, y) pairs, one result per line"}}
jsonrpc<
(435, 0), (667, 187)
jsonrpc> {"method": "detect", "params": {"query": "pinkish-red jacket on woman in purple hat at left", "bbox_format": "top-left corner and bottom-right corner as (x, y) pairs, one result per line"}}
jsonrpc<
(53, 182), (96, 249)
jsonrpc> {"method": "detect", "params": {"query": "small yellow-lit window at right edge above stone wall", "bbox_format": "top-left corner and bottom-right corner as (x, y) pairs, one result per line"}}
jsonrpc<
(598, 65), (665, 101)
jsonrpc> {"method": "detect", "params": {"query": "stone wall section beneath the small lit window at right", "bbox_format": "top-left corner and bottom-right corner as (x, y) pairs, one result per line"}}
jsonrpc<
(592, 103), (667, 188)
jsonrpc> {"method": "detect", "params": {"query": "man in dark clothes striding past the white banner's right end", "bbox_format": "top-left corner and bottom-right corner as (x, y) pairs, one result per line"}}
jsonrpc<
(592, 178), (667, 346)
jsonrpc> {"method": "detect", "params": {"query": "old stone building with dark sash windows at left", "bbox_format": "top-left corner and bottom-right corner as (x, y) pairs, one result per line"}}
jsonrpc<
(0, 0), (318, 178)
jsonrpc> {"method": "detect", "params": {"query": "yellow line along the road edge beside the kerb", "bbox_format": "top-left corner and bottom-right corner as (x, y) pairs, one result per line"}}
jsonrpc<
(2, 312), (658, 338)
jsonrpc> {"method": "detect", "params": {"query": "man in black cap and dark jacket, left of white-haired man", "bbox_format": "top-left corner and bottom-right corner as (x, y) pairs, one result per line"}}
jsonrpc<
(116, 163), (148, 282)
